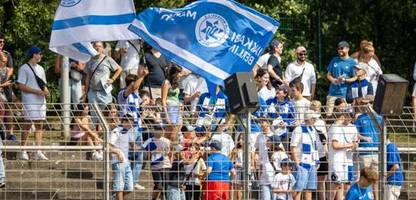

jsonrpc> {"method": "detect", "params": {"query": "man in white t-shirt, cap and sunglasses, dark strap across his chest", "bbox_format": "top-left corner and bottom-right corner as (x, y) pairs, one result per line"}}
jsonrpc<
(285, 46), (316, 100)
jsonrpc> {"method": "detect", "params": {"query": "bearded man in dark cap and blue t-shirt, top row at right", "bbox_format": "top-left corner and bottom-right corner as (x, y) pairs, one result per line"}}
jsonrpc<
(326, 41), (357, 116)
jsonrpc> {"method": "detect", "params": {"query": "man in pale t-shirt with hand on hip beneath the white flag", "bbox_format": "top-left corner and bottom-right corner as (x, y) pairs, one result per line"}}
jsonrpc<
(83, 42), (122, 108)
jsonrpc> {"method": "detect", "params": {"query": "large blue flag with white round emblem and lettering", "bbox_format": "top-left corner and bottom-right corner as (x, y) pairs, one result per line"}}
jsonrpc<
(129, 0), (279, 85)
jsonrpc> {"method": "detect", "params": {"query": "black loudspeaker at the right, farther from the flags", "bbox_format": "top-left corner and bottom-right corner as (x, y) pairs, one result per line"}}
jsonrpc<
(373, 74), (409, 115)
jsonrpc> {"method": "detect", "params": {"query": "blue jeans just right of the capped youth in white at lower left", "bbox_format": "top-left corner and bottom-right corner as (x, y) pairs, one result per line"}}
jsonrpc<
(130, 126), (143, 184)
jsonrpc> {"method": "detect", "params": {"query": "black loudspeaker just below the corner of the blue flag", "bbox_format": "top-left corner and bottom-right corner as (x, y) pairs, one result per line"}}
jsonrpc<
(225, 72), (259, 114)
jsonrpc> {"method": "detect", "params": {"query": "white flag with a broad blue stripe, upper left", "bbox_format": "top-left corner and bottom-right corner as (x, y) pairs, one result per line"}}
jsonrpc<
(49, 0), (138, 62)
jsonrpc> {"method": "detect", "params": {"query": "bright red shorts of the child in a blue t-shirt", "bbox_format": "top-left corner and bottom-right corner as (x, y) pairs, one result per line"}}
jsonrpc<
(202, 181), (230, 200)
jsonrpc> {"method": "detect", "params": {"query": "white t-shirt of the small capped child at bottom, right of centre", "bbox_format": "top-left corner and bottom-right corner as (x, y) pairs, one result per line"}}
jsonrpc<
(272, 173), (296, 200)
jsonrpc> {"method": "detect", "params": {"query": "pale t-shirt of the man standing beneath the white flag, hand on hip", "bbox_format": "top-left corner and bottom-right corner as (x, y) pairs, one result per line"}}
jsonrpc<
(86, 56), (118, 91)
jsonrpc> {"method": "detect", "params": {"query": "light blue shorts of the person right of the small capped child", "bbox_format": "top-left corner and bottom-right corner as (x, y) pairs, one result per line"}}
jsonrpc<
(293, 163), (317, 192)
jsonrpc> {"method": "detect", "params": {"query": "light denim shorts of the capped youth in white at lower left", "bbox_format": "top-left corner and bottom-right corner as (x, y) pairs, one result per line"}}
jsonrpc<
(112, 162), (133, 192)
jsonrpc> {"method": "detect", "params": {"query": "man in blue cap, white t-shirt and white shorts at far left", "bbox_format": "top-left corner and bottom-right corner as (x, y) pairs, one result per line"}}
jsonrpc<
(17, 46), (50, 160)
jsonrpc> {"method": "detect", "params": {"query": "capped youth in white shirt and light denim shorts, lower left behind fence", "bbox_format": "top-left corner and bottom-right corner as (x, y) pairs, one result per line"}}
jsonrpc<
(110, 114), (137, 200)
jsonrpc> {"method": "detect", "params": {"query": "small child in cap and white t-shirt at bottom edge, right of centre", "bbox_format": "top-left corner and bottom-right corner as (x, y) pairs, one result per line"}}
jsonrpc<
(272, 158), (296, 200)
